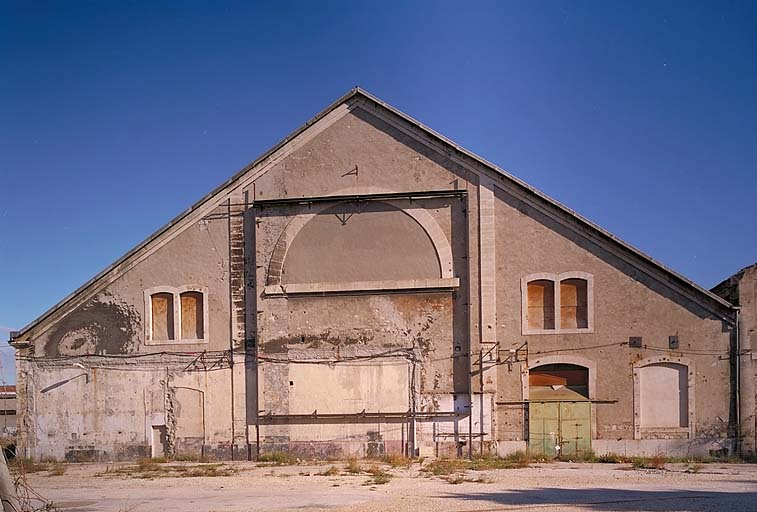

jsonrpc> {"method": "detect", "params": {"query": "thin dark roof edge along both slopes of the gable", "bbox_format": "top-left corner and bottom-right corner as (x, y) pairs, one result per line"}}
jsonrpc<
(10, 87), (733, 344)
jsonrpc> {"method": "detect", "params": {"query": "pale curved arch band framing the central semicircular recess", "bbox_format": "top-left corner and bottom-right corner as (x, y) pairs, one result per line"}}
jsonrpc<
(266, 187), (453, 285)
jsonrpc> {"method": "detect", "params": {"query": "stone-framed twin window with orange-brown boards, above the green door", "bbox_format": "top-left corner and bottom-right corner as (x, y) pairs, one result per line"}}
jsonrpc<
(521, 272), (594, 334)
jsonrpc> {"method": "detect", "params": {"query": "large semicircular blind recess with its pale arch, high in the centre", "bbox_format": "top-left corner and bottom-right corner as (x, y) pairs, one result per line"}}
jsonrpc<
(266, 201), (453, 287)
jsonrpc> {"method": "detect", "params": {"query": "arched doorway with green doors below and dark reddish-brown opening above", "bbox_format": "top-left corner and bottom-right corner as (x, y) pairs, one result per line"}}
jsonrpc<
(528, 363), (591, 457)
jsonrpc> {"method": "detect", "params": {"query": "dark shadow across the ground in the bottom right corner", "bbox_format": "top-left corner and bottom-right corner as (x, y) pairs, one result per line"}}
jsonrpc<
(439, 488), (757, 512)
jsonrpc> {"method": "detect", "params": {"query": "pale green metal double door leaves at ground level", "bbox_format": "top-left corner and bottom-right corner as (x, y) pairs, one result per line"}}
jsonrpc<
(528, 401), (591, 457)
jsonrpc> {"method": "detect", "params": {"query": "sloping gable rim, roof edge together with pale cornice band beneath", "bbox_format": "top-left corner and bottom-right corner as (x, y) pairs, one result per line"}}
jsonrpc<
(11, 87), (732, 346)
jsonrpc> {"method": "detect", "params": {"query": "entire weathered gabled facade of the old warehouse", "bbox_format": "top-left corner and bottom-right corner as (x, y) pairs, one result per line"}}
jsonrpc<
(11, 89), (754, 460)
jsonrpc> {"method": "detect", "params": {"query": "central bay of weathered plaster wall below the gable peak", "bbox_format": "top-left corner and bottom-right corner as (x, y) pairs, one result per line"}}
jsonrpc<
(245, 109), (476, 454)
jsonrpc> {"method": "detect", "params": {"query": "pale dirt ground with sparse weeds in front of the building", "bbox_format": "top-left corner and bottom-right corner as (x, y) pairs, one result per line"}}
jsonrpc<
(20, 462), (757, 512)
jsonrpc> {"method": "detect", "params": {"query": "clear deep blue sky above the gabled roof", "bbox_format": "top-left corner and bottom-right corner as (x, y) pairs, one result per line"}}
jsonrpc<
(0, 0), (757, 381)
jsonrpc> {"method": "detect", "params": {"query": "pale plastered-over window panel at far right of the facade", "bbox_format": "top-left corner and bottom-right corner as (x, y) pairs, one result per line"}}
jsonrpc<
(639, 363), (689, 429)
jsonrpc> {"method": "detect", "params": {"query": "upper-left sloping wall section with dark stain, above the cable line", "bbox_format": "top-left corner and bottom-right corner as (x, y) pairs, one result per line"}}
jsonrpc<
(34, 212), (229, 357)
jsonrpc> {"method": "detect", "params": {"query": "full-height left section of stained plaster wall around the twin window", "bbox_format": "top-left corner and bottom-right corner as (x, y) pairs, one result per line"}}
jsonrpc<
(19, 208), (238, 460)
